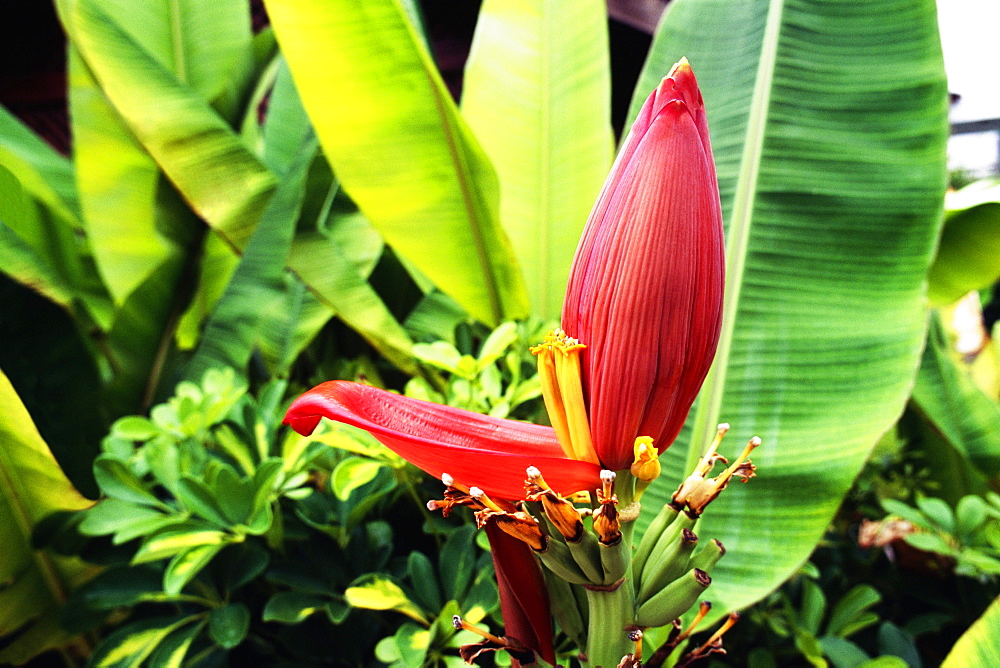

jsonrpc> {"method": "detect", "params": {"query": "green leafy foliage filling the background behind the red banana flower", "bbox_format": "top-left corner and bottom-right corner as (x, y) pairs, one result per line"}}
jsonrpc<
(0, 0), (1000, 667)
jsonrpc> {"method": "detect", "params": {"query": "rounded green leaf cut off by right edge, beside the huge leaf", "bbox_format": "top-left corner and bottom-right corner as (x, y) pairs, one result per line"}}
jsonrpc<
(928, 181), (1000, 305)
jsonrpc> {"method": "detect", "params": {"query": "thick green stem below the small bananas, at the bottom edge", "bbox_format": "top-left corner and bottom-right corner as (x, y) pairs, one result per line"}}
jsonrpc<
(586, 576), (635, 668)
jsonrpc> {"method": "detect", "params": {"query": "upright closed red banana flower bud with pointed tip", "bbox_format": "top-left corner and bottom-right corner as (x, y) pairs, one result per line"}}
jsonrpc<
(562, 60), (724, 470)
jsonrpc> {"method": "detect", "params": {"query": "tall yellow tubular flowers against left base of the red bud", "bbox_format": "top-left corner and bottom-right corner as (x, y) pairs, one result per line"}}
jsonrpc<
(531, 329), (599, 464)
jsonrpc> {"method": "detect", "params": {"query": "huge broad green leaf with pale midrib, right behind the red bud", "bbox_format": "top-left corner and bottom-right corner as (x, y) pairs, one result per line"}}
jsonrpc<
(633, 0), (947, 608)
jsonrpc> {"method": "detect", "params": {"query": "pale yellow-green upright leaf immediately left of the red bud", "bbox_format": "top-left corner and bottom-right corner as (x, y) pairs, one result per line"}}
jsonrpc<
(462, 0), (612, 319)
